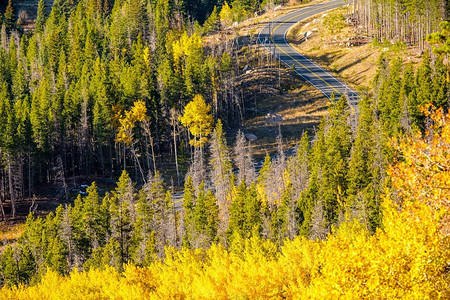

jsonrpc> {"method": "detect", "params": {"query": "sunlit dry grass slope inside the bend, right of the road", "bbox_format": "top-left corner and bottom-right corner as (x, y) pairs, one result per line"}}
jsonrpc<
(287, 7), (420, 91)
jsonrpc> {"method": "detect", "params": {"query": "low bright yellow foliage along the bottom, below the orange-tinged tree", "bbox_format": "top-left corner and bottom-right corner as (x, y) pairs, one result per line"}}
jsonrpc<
(0, 223), (448, 299)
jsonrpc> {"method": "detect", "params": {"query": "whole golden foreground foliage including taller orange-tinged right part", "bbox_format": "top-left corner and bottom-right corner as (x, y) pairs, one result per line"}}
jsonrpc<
(0, 111), (450, 299)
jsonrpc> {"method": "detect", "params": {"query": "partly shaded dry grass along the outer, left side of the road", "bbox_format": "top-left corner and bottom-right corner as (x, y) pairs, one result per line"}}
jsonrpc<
(204, 1), (334, 158)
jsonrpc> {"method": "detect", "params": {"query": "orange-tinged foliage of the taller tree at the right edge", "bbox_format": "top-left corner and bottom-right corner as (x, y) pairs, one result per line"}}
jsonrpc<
(388, 106), (450, 235)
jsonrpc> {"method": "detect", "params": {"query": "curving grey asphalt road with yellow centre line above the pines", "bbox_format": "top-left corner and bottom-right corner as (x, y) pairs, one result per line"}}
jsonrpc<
(258, 0), (359, 108)
